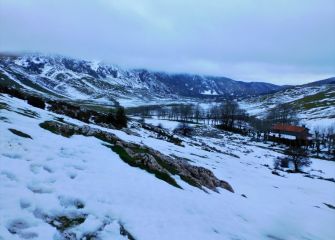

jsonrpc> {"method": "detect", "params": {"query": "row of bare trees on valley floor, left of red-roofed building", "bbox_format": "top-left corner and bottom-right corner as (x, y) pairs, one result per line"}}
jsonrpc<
(127, 100), (298, 132)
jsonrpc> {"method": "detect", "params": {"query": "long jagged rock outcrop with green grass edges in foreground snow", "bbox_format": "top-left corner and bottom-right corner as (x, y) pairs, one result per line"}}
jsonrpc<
(40, 121), (234, 192)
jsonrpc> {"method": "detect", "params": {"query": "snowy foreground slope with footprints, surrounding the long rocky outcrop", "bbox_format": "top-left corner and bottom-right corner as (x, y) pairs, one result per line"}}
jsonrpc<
(0, 94), (335, 240)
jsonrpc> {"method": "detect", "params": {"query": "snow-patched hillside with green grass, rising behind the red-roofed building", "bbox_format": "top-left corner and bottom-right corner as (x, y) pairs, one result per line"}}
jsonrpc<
(241, 78), (335, 128)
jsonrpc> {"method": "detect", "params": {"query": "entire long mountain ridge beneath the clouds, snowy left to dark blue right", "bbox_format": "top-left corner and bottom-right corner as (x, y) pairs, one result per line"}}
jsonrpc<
(0, 54), (281, 101)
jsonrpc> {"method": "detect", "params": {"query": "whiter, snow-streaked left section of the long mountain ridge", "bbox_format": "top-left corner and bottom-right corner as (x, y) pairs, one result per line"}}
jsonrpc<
(0, 55), (171, 105)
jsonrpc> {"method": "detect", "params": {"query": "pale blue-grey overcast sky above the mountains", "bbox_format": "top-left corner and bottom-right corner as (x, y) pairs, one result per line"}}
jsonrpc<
(0, 0), (335, 84)
